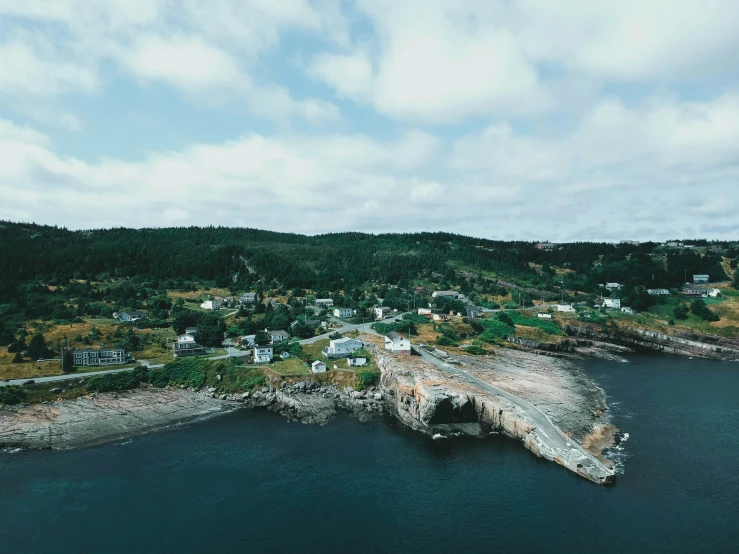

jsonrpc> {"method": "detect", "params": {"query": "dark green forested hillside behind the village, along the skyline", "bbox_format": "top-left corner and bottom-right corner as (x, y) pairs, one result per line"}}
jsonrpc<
(0, 221), (738, 301)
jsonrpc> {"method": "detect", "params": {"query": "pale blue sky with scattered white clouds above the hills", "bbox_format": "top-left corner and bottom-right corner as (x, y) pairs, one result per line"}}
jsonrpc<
(0, 0), (739, 241)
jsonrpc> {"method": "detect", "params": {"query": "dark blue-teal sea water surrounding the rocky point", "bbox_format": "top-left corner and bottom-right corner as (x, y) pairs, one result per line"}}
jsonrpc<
(0, 357), (739, 553)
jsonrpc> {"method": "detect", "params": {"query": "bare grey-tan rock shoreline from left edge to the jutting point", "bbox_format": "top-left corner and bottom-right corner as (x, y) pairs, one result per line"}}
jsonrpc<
(0, 349), (614, 484)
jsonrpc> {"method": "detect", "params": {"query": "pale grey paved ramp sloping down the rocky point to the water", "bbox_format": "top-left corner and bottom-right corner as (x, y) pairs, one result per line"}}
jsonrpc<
(417, 348), (610, 472)
